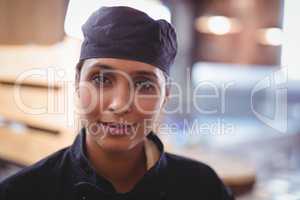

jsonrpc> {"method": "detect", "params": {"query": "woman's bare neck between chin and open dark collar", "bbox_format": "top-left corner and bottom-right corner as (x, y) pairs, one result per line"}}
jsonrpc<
(86, 136), (146, 193)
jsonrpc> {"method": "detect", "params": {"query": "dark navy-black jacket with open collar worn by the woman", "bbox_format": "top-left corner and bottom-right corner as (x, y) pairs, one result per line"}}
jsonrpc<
(0, 129), (233, 200)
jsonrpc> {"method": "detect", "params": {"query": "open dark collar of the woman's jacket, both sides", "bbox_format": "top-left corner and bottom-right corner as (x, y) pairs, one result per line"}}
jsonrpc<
(70, 128), (167, 198)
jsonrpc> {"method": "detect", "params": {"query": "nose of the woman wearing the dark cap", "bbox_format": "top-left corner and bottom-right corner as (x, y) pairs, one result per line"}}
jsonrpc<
(108, 83), (134, 114)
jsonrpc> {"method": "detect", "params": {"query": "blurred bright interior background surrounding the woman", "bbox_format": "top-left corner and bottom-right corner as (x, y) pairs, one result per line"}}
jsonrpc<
(0, 0), (300, 200)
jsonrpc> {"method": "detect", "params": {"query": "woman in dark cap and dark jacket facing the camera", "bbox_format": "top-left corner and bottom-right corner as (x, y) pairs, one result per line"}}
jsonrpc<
(0, 7), (233, 200)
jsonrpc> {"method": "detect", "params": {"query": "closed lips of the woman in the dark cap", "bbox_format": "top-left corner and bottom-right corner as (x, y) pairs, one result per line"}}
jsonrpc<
(100, 122), (134, 136)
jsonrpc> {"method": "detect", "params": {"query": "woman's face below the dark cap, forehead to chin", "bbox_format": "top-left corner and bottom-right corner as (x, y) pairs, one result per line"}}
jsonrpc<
(77, 58), (168, 152)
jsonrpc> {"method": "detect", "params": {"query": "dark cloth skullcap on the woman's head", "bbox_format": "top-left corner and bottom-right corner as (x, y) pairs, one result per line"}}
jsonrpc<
(80, 6), (177, 74)
